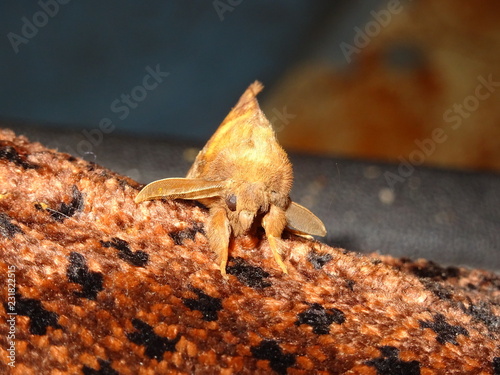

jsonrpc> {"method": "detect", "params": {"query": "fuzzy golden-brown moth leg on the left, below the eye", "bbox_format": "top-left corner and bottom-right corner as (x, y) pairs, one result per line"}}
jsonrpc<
(207, 207), (231, 279)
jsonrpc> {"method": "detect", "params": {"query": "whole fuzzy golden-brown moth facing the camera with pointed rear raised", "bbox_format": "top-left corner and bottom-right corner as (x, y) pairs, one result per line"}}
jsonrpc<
(135, 81), (326, 277)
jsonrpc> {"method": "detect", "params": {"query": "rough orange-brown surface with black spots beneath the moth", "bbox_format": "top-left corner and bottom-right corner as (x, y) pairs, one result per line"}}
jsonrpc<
(0, 130), (500, 375)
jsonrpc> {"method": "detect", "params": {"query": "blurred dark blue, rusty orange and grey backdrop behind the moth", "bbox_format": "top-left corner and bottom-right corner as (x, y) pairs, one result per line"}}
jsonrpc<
(0, 0), (500, 269)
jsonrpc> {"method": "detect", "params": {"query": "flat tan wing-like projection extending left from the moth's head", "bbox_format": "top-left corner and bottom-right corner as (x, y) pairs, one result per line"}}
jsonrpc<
(135, 178), (224, 203)
